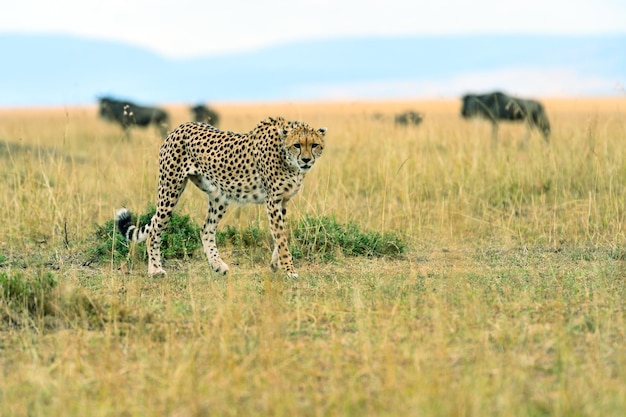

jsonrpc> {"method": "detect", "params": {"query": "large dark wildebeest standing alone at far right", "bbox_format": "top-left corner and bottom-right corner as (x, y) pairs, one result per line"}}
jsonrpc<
(461, 91), (550, 143)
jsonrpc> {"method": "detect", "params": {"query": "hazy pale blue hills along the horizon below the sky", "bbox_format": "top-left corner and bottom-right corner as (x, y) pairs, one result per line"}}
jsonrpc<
(0, 34), (626, 106)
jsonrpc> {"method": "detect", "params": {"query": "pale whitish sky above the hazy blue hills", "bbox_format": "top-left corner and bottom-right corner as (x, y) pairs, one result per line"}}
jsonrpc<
(0, 0), (626, 58)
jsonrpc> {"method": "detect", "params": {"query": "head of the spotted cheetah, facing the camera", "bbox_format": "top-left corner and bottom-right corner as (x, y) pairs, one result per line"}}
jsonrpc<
(281, 122), (326, 173)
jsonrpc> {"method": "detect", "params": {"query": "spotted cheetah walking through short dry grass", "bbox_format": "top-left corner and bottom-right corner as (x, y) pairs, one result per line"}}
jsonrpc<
(115, 117), (326, 278)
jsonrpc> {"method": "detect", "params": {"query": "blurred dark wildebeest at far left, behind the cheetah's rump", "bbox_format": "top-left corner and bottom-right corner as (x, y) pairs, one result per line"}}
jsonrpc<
(98, 97), (169, 137)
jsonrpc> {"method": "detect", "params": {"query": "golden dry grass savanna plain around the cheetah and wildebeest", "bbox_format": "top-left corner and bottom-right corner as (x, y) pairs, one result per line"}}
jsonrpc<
(0, 97), (626, 417)
